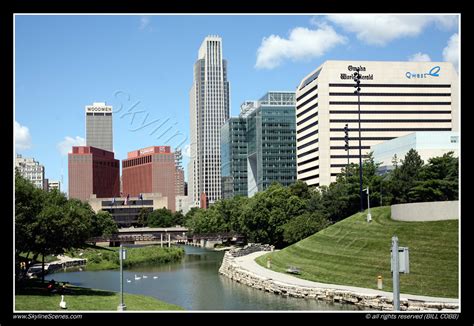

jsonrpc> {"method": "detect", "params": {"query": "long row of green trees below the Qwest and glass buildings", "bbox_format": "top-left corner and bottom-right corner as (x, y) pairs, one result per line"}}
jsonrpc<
(185, 150), (459, 247)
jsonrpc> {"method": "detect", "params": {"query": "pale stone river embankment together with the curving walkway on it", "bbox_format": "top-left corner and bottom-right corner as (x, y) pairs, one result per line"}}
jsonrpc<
(219, 244), (459, 312)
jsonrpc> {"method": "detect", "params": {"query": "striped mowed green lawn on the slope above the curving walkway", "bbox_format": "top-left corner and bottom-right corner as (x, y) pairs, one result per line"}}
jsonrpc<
(257, 207), (459, 298)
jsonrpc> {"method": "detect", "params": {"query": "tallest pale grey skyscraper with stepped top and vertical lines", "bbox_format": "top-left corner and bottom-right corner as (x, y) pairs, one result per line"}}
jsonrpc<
(188, 36), (229, 206)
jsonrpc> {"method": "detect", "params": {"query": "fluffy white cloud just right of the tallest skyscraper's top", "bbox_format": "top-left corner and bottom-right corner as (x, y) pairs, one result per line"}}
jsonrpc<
(255, 24), (346, 69)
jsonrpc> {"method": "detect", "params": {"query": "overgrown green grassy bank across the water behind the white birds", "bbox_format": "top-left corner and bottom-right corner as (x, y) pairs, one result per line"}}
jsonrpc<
(66, 245), (184, 270)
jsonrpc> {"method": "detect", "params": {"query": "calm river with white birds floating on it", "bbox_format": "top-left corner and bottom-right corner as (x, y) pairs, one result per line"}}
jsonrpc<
(46, 246), (358, 311)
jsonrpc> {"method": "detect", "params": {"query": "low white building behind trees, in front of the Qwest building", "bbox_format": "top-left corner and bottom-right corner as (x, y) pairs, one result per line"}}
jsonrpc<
(371, 131), (460, 173)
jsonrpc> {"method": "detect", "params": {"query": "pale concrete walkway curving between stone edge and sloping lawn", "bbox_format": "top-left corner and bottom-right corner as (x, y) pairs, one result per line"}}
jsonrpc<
(234, 251), (459, 305)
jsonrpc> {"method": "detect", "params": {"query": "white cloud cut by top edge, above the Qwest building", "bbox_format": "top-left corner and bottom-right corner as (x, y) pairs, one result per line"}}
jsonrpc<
(326, 14), (457, 46)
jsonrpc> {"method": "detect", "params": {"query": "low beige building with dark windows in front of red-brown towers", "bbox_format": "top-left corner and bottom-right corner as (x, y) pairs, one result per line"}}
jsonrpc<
(88, 193), (168, 227)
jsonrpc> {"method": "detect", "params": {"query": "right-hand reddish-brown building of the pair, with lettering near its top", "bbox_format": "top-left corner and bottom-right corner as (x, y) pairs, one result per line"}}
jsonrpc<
(122, 146), (177, 212)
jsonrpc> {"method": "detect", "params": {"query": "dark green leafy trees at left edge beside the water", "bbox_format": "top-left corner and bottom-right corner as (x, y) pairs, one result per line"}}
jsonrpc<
(15, 171), (118, 282)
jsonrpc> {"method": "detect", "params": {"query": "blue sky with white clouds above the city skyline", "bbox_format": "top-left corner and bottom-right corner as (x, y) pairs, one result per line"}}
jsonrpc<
(14, 14), (460, 191)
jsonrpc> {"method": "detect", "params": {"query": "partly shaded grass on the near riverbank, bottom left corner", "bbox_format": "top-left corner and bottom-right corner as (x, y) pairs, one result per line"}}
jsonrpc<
(15, 280), (184, 311)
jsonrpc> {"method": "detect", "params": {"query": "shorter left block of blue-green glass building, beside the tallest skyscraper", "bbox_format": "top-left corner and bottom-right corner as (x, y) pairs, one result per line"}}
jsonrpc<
(221, 117), (247, 198)
